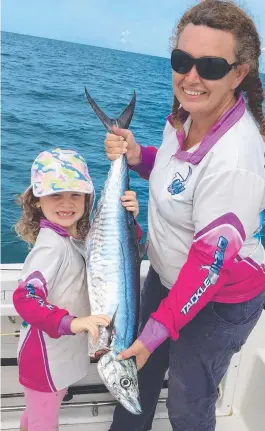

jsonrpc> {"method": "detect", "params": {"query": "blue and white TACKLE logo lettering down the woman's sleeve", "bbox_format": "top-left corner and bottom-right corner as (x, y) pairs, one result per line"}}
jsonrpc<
(181, 236), (228, 315)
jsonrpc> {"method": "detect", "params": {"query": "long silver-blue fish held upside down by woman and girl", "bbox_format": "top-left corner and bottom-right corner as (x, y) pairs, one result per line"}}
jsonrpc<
(85, 89), (141, 414)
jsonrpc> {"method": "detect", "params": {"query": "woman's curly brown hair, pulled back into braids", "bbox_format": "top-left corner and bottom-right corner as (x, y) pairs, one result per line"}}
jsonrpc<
(171, 0), (265, 135)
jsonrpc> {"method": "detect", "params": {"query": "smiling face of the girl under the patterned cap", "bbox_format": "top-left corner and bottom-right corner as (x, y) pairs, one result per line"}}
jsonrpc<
(39, 192), (85, 236)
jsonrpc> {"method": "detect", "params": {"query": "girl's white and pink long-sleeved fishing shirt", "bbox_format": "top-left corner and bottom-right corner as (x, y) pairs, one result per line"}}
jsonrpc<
(13, 220), (90, 392)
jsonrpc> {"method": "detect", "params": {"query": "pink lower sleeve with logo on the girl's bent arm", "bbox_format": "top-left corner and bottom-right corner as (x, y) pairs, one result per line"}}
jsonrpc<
(13, 271), (69, 338)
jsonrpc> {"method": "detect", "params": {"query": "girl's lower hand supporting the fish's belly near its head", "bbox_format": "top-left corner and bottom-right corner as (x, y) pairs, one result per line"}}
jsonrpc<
(70, 314), (111, 343)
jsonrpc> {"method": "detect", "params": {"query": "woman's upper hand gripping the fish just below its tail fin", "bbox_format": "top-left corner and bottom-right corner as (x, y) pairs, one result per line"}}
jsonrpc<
(104, 126), (141, 166)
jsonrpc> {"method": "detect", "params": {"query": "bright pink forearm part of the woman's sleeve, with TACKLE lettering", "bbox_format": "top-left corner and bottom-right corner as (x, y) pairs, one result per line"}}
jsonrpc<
(151, 231), (231, 340)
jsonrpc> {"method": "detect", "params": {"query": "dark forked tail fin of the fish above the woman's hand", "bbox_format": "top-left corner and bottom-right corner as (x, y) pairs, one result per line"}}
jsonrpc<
(85, 87), (136, 133)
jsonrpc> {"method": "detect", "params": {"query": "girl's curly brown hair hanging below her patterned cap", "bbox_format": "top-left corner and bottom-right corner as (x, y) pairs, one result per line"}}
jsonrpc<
(15, 188), (90, 244)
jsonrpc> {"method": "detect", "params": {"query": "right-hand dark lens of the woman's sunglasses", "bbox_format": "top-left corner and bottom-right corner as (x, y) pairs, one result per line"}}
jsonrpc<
(197, 57), (230, 81)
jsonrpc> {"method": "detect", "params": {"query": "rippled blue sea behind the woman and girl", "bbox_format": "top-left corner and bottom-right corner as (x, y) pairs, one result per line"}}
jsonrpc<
(2, 32), (265, 263)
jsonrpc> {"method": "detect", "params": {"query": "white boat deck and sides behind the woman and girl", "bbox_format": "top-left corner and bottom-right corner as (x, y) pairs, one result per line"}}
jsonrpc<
(0, 261), (265, 431)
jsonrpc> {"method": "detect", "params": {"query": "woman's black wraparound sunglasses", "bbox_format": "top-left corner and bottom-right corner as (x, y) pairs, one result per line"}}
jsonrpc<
(171, 49), (238, 81)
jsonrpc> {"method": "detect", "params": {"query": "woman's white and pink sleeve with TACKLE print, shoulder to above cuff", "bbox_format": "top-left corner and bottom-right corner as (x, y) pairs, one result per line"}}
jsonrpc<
(144, 169), (264, 340)
